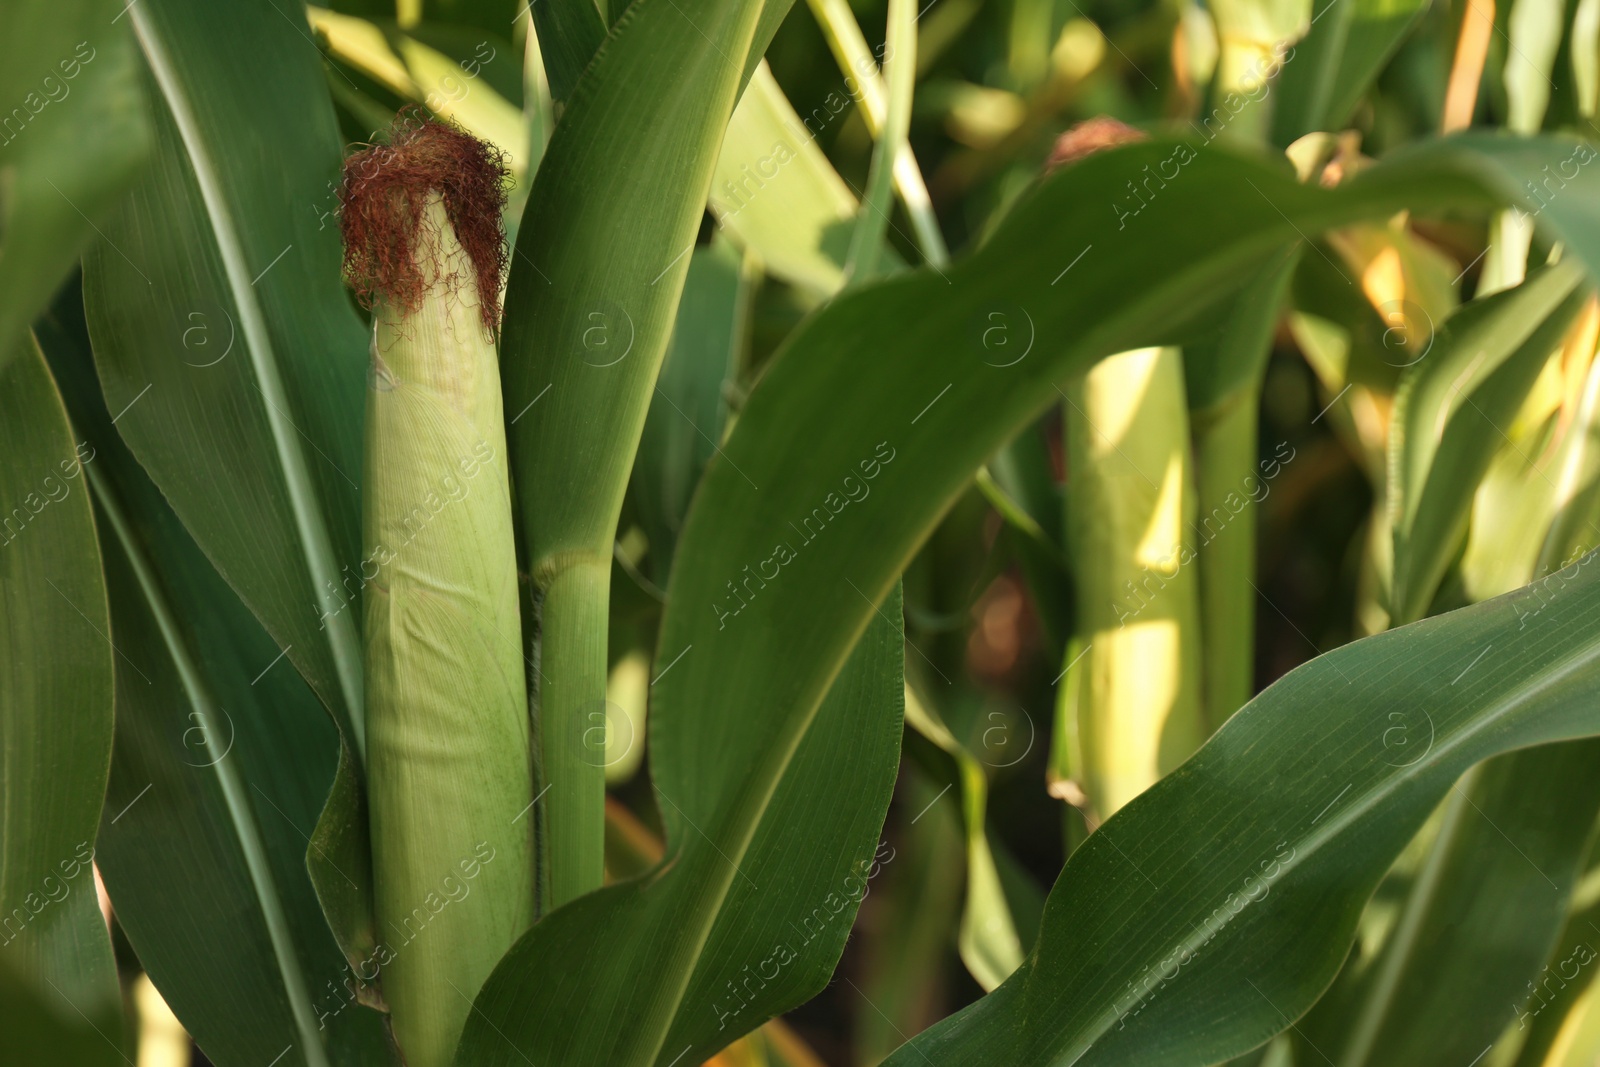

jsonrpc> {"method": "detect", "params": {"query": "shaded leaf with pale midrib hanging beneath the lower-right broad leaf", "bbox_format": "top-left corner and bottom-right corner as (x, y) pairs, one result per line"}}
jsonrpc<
(1301, 734), (1600, 1067)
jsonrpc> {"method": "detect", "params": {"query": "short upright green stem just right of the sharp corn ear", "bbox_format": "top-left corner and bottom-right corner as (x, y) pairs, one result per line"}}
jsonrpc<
(539, 558), (611, 909)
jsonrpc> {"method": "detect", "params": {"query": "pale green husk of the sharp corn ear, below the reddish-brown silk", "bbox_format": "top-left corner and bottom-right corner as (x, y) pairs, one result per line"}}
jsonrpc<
(347, 137), (534, 1067)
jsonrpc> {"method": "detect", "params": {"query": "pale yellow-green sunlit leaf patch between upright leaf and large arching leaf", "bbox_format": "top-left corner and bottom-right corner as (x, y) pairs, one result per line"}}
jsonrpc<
(709, 62), (856, 299)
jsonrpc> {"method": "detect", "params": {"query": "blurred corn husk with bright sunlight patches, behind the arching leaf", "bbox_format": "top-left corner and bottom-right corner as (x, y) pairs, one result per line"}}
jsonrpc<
(1061, 349), (1205, 819)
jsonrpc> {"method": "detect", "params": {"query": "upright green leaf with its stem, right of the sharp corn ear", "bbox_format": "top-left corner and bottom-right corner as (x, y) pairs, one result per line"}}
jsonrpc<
(499, 0), (774, 905)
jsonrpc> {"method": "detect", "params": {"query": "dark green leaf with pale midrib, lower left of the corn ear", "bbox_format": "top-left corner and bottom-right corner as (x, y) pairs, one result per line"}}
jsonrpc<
(38, 296), (394, 1067)
